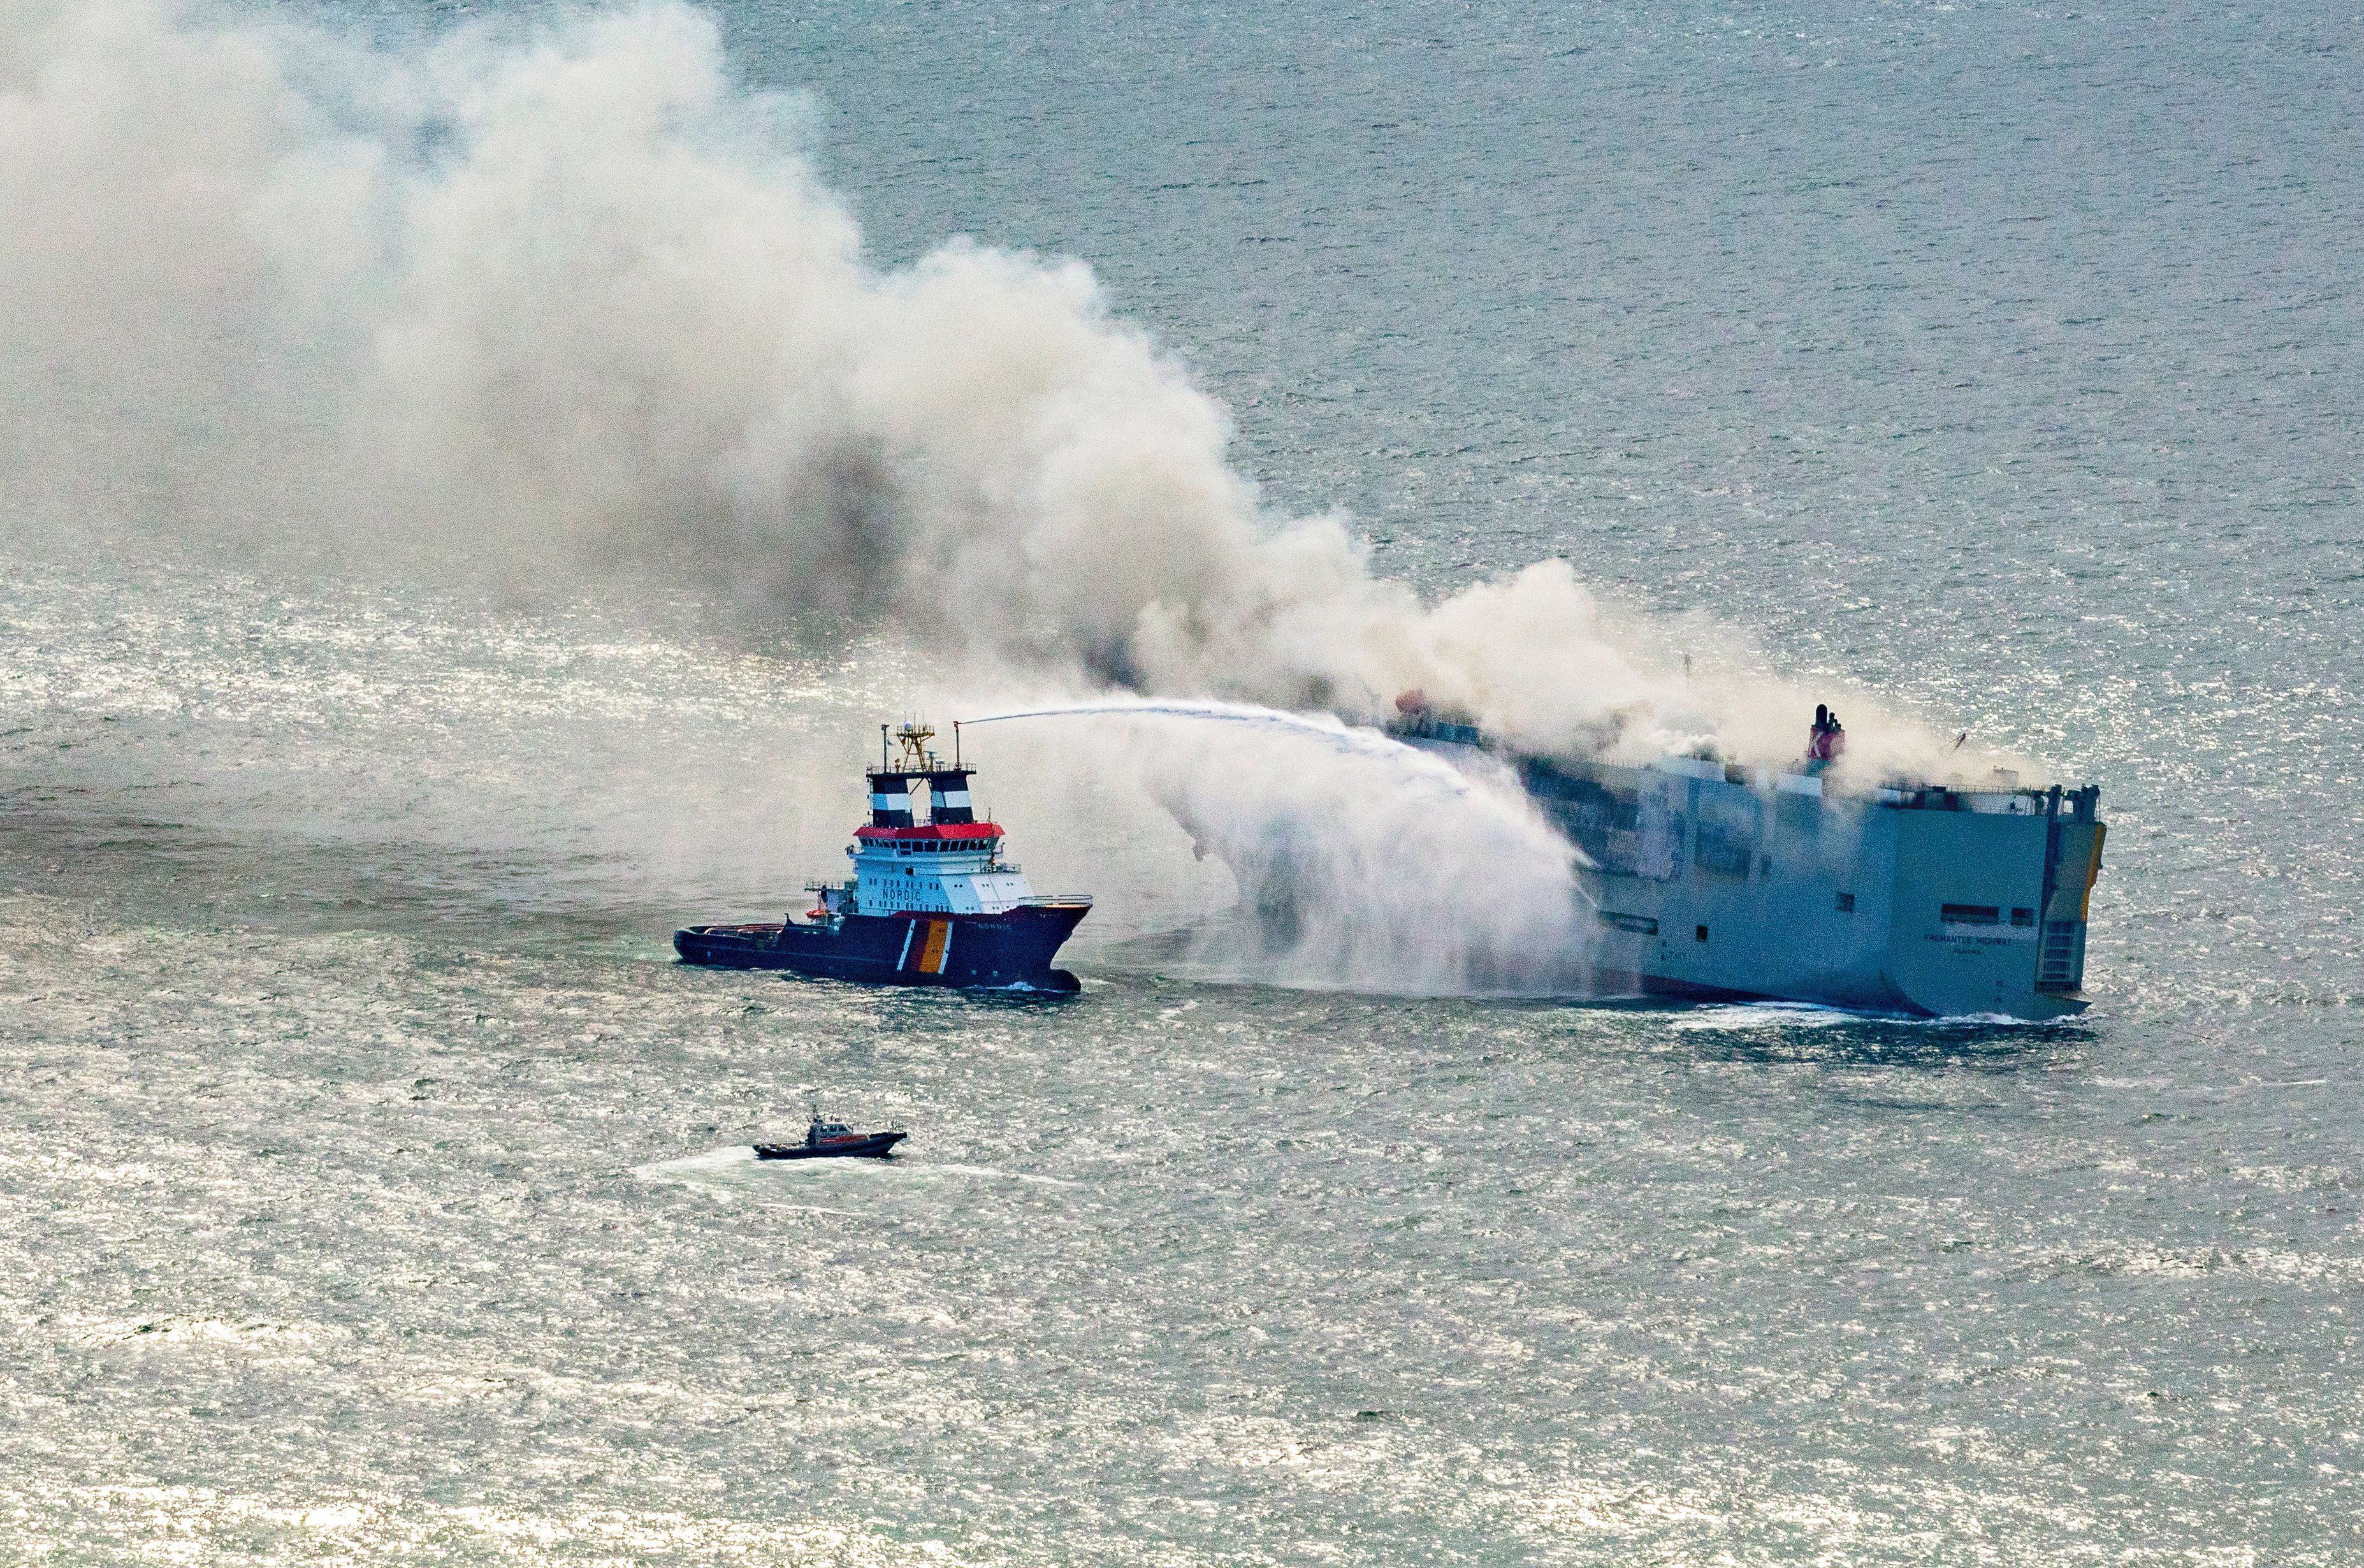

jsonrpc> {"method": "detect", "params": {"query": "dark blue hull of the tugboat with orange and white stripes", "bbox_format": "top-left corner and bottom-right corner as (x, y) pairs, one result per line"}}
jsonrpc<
(674, 901), (1092, 991)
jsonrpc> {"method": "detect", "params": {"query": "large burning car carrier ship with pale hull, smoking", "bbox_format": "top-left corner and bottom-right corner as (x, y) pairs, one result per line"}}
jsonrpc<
(1388, 693), (2107, 1019)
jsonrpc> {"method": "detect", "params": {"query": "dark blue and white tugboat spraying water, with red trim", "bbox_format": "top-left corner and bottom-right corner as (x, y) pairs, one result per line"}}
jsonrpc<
(674, 723), (1092, 991)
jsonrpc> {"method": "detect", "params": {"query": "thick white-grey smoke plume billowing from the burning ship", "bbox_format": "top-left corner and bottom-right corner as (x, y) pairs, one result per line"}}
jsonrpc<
(0, 0), (2005, 785)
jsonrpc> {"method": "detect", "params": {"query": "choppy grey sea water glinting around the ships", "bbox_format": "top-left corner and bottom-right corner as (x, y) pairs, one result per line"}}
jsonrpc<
(0, 4), (2364, 1564)
